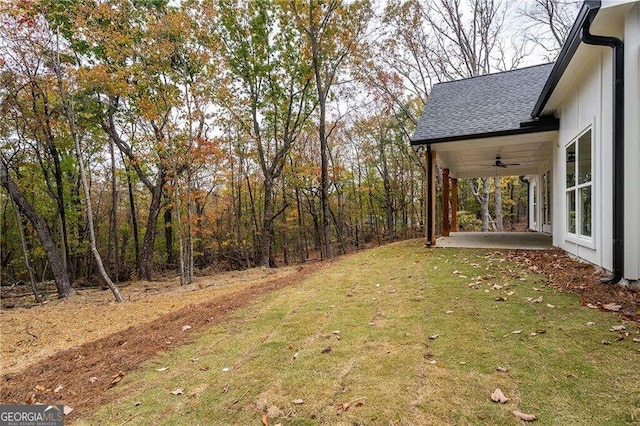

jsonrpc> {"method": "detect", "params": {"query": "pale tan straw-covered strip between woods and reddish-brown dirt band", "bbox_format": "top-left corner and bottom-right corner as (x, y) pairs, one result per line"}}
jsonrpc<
(0, 267), (296, 374)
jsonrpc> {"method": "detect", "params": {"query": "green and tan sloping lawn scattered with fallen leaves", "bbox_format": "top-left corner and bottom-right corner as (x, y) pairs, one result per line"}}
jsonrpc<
(80, 241), (640, 425)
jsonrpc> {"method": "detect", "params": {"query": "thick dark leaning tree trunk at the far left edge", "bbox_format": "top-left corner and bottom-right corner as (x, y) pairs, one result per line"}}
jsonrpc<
(0, 158), (75, 298)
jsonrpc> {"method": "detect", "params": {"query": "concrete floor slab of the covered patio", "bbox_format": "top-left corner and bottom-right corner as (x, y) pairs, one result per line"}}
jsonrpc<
(436, 232), (553, 250)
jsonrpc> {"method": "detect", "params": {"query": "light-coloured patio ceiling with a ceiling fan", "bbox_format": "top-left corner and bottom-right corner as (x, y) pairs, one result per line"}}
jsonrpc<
(420, 131), (558, 178)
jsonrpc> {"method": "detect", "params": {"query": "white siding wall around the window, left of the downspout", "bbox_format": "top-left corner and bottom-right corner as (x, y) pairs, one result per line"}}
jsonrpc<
(552, 46), (613, 270)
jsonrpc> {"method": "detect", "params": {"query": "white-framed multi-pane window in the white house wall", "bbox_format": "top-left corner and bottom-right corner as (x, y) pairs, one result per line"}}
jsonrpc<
(565, 129), (593, 238)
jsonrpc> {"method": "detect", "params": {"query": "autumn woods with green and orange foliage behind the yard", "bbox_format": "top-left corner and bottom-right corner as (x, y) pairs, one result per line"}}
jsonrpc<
(0, 0), (570, 299)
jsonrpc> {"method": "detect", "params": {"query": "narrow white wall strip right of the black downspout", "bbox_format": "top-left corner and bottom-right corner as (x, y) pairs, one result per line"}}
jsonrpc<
(624, 4), (640, 280)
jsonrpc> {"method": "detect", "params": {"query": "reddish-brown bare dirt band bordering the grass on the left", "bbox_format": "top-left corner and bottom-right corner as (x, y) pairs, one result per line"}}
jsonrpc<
(0, 262), (328, 419)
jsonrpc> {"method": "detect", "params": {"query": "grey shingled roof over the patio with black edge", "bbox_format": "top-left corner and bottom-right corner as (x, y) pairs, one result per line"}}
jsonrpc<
(411, 64), (558, 145)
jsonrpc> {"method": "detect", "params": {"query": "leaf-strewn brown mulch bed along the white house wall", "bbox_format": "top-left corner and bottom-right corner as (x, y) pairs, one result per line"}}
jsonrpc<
(508, 250), (640, 322)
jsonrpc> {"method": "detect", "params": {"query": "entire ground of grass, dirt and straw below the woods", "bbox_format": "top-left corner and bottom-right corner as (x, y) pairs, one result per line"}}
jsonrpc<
(0, 241), (640, 424)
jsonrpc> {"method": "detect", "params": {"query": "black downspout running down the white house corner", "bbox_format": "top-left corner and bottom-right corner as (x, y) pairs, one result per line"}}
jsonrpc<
(580, 19), (624, 284)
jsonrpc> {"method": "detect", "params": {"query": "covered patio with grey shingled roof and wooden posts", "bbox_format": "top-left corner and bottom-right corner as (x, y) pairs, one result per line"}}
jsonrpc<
(411, 64), (559, 249)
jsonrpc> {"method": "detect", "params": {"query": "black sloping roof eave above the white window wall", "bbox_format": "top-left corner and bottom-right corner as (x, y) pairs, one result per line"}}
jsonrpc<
(531, 0), (600, 118)
